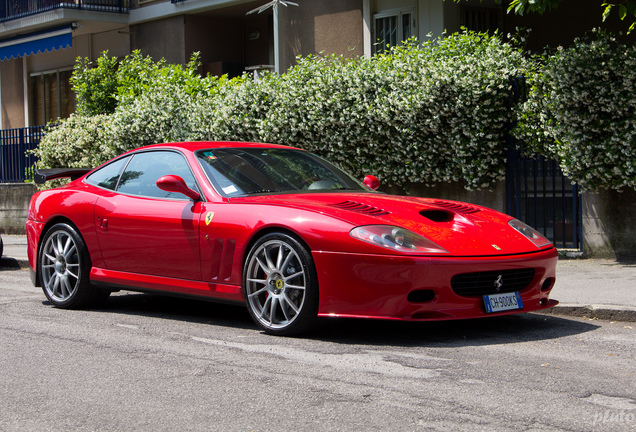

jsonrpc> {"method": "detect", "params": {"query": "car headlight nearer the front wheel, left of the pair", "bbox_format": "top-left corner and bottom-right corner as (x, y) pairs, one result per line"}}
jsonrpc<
(349, 225), (448, 254)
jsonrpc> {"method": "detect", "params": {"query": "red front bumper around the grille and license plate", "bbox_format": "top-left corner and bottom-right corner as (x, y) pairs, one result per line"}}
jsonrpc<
(313, 248), (558, 321)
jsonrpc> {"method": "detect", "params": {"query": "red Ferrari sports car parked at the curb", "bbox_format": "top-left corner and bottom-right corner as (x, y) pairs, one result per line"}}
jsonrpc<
(27, 142), (557, 335)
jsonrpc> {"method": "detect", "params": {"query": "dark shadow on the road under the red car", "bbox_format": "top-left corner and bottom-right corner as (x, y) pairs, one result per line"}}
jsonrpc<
(62, 292), (599, 347)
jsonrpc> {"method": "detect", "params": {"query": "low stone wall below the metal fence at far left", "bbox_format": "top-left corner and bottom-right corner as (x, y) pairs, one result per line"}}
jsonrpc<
(0, 183), (37, 234)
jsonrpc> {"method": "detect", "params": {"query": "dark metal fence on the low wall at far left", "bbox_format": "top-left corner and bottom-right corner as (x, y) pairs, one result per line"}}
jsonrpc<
(0, 126), (46, 183)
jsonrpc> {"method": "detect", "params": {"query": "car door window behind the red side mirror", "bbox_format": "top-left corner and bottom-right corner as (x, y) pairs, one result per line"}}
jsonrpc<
(117, 151), (198, 200)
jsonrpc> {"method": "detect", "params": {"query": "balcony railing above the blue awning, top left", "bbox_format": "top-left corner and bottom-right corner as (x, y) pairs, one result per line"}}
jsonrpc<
(0, 0), (131, 22)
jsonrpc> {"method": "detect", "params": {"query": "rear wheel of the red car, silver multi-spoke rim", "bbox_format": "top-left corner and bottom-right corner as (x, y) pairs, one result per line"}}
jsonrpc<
(38, 223), (110, 309)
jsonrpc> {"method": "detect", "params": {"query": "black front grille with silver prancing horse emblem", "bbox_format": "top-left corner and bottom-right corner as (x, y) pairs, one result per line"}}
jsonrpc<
(451, 268), (534, 297)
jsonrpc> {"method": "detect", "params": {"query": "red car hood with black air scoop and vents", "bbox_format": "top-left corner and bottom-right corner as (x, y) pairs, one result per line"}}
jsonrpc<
(232, 192), (552, 256)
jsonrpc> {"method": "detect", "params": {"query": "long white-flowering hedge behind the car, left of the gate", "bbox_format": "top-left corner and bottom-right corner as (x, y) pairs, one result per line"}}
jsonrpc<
(38, 33), (528, 189)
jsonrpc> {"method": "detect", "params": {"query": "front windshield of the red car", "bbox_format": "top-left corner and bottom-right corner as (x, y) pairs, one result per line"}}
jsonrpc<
(196, 148), (368, 197)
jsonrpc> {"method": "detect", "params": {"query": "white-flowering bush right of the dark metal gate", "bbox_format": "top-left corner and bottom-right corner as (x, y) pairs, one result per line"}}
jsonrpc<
(514, 34), (636, 191)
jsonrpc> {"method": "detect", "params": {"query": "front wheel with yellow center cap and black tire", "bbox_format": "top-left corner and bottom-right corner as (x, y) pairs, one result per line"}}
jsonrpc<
(243, 233), (318, 336)
